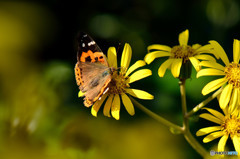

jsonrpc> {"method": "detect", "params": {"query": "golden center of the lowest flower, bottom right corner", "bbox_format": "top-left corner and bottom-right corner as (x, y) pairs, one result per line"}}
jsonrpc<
(222, 116), (240, 136)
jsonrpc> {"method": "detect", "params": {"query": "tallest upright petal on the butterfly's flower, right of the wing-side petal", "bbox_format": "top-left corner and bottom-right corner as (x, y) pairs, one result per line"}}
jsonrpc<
(121, 43), (132, 71)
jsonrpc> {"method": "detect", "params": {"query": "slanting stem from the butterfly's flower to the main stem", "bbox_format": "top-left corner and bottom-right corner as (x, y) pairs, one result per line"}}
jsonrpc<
(130, 97), (182, 132)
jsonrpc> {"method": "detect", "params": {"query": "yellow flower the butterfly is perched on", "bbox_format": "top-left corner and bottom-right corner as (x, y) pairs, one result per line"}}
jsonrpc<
(79, 43), (153, 120)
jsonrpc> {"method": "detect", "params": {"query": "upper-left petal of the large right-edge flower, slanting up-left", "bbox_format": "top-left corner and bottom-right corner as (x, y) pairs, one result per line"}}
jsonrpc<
(209, 40), (229, 66)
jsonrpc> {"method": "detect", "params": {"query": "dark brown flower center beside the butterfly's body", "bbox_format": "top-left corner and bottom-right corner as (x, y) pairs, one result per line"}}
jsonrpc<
(108, 71), (130, 94)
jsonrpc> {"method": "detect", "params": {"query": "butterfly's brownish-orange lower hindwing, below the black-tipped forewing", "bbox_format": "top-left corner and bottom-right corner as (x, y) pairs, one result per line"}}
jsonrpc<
(75, 62), (111, 107)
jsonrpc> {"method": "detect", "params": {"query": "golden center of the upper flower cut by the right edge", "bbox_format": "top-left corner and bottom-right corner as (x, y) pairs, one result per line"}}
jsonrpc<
(224, 62), (240, 88)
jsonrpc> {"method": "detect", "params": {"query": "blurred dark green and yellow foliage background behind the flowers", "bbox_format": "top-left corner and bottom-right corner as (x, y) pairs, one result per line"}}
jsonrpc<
(0, 0), (240, 159)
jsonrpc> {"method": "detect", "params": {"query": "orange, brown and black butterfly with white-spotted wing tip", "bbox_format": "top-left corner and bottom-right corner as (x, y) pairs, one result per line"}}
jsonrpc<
(75, 33), (114, 107)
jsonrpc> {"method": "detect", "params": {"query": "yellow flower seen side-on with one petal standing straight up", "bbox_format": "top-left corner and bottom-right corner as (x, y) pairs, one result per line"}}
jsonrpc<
(144, 30), (215, 78)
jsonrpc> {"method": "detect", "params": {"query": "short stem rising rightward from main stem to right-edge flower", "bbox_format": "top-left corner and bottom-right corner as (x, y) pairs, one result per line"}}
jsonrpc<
(186, 88), (223, 117)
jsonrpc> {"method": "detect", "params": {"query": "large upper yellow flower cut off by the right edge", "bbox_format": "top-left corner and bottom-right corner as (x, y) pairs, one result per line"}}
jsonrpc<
(197, 39), (240, 112)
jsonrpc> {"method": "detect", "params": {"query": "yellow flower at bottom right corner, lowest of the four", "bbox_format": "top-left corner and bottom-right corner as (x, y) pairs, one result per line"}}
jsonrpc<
(196, 108), (240, 157)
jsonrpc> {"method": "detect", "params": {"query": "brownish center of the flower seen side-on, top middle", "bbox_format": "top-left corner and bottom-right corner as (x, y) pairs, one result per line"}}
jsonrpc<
(171, 45), (195, 63)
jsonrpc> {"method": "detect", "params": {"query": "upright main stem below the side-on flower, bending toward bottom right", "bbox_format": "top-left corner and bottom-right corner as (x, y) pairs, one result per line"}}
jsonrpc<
(179, 79), (207, 157)
